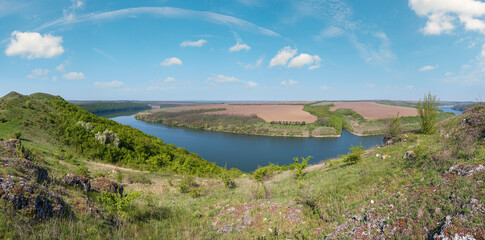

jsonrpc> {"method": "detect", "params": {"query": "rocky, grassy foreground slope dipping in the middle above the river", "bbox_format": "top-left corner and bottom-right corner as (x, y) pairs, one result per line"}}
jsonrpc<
(0, 93), (485, 239)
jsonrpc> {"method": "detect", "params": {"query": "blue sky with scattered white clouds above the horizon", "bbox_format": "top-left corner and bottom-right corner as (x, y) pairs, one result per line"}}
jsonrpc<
(0, 0), (485, 101)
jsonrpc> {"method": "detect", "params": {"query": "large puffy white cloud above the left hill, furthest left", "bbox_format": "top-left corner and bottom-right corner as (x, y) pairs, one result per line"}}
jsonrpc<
(5, 31), (64, 59)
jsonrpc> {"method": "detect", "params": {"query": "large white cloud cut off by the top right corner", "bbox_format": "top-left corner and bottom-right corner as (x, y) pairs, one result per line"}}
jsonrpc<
(409, 0), (485, 35)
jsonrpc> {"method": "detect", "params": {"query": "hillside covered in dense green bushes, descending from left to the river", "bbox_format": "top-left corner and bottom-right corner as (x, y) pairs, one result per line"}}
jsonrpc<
(0, 92), (221, 176)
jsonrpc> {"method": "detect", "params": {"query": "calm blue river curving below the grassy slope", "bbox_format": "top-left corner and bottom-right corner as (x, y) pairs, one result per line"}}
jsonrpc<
(112, 115), (383, 172)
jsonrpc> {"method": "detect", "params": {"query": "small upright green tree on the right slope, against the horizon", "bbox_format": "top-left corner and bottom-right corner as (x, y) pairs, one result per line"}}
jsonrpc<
(416, 92), (440, 134)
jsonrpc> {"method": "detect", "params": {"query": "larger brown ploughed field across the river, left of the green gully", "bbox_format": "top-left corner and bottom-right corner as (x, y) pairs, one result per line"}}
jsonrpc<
(168, 103), (317, 123)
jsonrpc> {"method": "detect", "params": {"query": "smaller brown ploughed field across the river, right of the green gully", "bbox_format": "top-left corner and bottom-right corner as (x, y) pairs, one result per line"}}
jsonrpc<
(318, 102), (418, 119)
